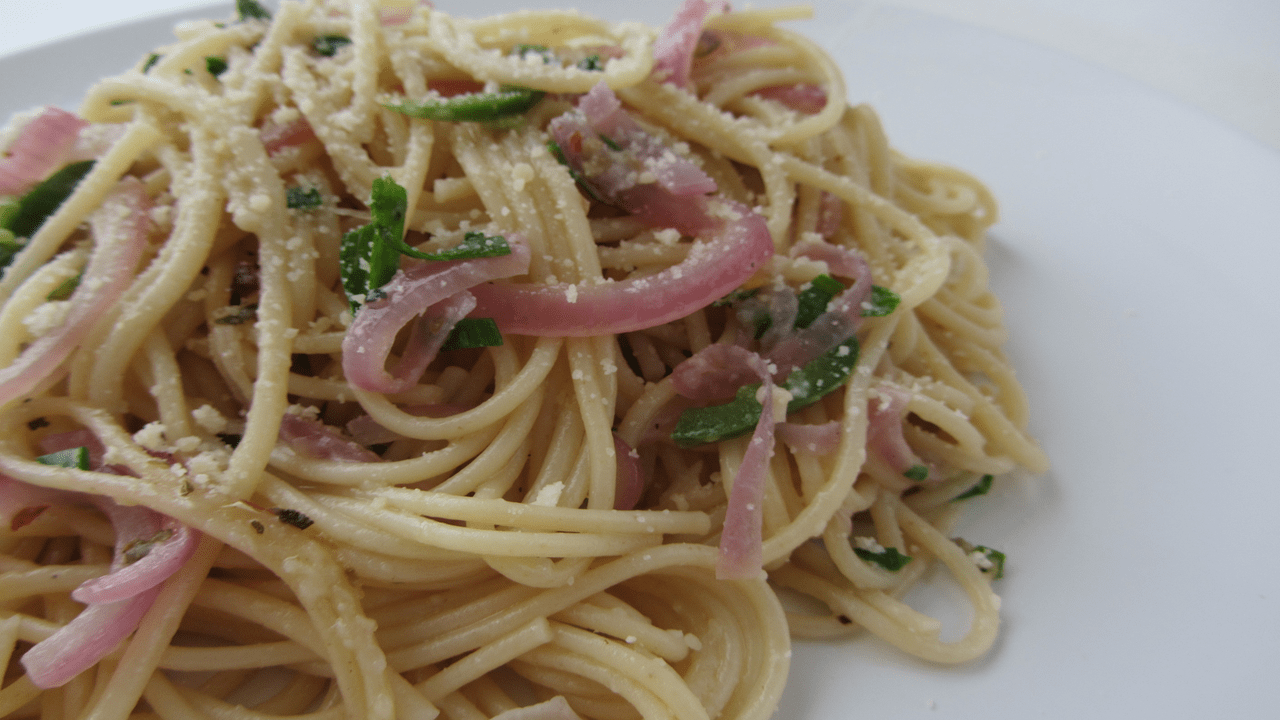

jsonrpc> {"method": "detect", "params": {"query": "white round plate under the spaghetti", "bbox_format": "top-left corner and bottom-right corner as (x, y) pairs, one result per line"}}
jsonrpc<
(0, 0), (1280, 720)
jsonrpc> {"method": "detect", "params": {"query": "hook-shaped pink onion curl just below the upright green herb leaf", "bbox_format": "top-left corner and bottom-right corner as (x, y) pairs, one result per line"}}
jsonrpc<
(342, 234), (530, 393)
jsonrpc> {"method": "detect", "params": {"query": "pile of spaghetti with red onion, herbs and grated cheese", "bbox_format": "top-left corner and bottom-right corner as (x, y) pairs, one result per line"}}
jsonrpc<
(0, 0), (1044, 720)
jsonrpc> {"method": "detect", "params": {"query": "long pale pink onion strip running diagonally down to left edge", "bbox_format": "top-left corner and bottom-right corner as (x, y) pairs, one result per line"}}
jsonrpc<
(0, 176), (151, 406)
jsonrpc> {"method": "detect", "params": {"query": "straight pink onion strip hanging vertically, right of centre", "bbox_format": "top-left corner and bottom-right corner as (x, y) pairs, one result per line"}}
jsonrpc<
(704, 346), (774, 580)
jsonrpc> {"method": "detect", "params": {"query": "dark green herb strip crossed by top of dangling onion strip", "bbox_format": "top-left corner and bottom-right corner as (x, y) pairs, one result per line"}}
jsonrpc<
(671, 337), (858, 447)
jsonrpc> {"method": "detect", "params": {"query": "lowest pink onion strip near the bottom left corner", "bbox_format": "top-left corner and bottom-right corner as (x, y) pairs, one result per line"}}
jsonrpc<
(22, 579), (160, 689)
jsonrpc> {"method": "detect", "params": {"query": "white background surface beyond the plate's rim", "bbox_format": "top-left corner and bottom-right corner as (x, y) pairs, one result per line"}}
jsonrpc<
(0, 0), (1280, 149)
